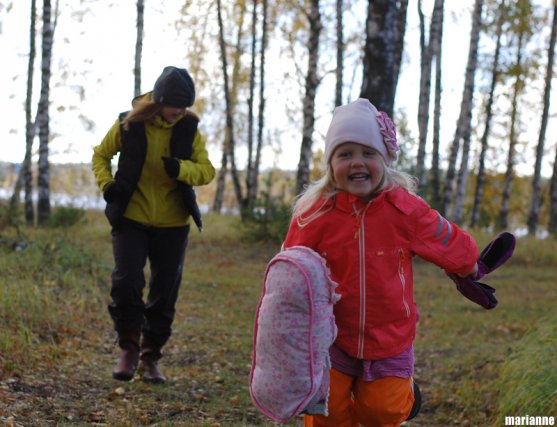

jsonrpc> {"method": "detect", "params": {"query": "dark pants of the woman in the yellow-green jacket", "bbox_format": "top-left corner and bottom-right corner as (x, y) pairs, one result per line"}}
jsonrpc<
(108, 219), (189, 348)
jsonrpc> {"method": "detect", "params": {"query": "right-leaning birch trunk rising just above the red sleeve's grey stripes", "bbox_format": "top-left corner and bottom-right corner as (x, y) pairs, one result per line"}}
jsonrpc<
(441, 0), (483, 219)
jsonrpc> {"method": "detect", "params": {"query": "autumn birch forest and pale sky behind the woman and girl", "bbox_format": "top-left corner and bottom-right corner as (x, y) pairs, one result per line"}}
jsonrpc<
(0, 0), (557, 236)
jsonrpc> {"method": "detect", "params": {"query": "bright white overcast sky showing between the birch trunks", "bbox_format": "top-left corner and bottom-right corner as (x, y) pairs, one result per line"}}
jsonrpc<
(0, 0), (557, 174)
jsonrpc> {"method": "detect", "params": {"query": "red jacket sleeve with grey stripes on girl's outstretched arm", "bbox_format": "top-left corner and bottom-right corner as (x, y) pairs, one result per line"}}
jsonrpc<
(412, 202), (479, 274)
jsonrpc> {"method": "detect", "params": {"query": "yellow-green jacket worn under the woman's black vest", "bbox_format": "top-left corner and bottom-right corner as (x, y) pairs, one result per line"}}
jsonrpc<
(92, 112), (215, 227)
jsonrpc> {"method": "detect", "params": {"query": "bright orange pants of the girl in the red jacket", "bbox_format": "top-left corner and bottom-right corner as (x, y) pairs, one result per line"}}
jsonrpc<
(304, 369), (414, 427)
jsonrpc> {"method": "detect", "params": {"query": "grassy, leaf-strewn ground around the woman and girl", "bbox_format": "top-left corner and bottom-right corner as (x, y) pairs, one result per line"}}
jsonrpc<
(0, 212), (557, 426)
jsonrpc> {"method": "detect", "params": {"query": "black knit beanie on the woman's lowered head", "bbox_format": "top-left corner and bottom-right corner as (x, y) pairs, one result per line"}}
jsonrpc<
(153, 66), (195, 108)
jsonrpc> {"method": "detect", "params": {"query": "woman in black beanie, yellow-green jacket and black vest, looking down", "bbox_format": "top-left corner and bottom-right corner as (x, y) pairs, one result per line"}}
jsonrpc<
(93, 66), (215, 383)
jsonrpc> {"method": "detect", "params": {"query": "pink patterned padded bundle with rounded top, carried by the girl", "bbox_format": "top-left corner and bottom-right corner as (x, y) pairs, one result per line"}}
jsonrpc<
(249, 246), (340, 422)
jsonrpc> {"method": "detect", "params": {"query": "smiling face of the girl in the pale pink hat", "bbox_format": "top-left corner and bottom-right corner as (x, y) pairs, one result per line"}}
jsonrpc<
(331, 142), (385, 200)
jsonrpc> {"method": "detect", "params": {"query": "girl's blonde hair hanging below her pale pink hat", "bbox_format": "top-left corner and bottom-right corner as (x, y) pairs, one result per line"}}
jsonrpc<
(292, 157), (417, 222)
